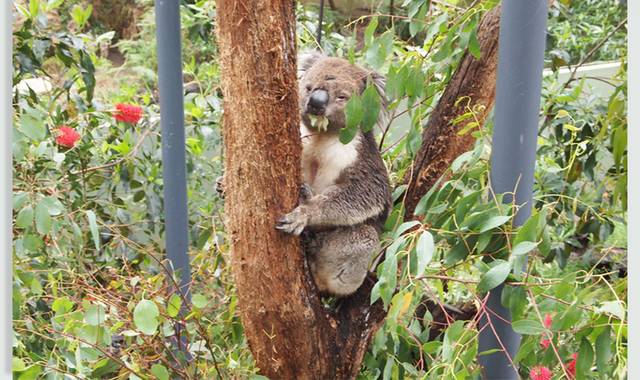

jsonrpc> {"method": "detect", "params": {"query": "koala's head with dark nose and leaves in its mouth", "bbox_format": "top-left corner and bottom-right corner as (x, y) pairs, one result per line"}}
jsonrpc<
(298, 53), (385, 132)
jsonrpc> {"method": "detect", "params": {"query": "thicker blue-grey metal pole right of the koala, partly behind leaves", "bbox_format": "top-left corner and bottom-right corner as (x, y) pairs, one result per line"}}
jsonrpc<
(479, 0), (548, 380)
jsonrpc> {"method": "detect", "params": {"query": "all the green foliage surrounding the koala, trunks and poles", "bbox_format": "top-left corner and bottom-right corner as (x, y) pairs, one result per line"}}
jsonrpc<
(13, 0), (627, 379)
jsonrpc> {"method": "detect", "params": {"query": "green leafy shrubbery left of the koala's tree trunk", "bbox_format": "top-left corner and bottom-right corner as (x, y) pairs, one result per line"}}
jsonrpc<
(13, 1), (235, 379)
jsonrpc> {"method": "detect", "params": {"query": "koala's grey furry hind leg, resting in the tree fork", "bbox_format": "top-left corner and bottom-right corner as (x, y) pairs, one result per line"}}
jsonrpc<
(309, 225), (378, 296)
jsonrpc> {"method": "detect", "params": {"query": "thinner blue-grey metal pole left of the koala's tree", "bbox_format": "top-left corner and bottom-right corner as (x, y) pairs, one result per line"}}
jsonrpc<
(155, 0), (191, 297)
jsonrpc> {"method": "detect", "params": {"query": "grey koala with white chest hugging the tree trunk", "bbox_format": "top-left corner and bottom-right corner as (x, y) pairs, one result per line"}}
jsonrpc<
(276, 53), (392, 297)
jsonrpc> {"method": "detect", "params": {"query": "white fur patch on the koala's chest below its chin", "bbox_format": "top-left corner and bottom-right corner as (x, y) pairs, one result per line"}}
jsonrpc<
(300, 125), (360, 194)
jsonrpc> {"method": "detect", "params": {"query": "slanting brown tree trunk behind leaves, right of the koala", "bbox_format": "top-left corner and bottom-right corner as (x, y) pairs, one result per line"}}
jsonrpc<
(405, 6), (500, 218)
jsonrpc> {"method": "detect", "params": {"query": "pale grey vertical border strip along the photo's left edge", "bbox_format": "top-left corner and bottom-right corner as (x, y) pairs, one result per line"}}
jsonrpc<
(0, 1), (13, 379)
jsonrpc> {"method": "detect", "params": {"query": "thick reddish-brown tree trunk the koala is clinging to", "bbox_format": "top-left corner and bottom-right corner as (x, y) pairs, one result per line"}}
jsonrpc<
(217, 0), (385, 379)
